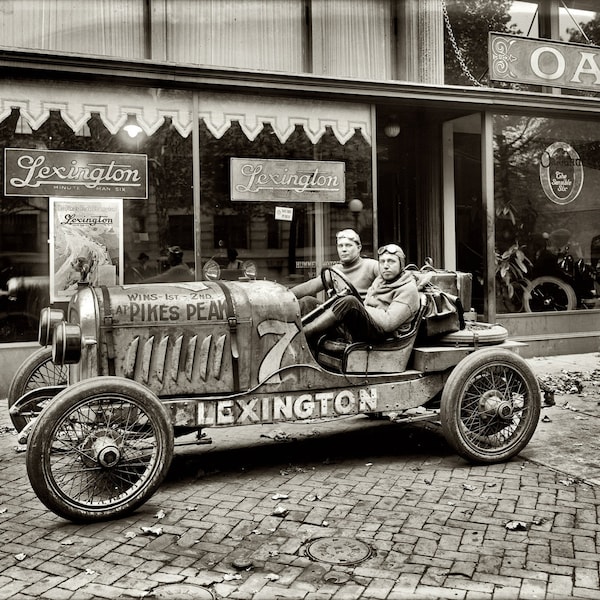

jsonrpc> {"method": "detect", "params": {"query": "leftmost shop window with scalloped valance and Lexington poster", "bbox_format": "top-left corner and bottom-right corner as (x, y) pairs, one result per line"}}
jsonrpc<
(0, 82), (195, 343)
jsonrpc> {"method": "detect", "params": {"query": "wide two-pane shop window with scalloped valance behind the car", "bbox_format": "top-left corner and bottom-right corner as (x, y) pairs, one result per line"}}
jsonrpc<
(0, 80), (373, 343)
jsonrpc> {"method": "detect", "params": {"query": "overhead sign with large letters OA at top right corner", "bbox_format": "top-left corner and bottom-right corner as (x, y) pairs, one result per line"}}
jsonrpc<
(488, 33), (600, 92)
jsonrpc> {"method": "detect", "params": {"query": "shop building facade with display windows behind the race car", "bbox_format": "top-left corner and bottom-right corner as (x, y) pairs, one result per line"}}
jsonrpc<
(0, 0), (600, 394)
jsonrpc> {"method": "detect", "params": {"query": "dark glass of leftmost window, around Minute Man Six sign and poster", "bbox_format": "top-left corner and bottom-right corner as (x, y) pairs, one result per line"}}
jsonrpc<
(0, 85), (195, 343)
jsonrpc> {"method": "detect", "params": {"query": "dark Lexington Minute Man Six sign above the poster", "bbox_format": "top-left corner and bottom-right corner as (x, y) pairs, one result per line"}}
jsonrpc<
(4, 148), (148, 198)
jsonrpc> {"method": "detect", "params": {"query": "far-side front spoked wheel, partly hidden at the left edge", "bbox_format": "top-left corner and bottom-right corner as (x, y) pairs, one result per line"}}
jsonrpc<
(8, 347), (68, 431)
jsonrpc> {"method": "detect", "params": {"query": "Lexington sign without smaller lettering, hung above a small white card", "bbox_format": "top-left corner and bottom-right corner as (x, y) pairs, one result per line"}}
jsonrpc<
(230, 158), (346, 202)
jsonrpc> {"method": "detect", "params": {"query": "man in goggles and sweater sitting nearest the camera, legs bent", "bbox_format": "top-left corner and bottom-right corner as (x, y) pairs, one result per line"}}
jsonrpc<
(304, 244), (420, 342)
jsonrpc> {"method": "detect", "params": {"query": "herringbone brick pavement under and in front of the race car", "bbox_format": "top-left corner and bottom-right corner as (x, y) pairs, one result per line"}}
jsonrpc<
(0, 354), (600, 600)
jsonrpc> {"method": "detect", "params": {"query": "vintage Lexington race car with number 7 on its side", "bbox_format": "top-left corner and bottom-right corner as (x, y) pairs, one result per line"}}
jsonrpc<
(9, 269), (541, 521)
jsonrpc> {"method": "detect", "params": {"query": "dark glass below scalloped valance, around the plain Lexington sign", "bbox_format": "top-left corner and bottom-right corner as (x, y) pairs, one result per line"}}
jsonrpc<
(200, 121), (373, 284)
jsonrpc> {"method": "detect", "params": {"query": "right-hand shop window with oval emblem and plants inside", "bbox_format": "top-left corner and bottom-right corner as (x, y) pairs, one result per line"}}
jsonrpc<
(494, 115), (600, 313)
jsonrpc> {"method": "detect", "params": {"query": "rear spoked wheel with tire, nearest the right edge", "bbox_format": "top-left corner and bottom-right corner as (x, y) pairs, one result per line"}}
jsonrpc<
(440, 348), (541, 464)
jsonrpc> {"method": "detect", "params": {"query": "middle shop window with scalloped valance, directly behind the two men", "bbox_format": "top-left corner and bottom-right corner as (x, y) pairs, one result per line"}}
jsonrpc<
(199, 94), (373, 285)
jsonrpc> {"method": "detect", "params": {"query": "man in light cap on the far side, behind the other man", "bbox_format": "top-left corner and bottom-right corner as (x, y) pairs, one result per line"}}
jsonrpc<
(290, 229), (379, 315)
